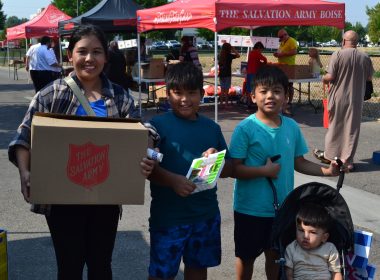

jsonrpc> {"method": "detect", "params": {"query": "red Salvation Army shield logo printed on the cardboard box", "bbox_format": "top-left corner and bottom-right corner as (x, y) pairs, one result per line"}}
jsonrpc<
(66, 142), (109, 189)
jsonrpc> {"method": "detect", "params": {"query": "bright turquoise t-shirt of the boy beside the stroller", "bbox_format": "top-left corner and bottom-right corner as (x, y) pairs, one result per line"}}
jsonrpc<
(230, 114), (308, 217)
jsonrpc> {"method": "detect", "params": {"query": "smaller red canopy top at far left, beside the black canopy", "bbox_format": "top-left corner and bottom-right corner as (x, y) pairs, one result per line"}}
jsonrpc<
(7, 4), (71, 40)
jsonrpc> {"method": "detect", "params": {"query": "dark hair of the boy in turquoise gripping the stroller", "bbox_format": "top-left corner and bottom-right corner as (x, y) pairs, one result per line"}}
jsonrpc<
(252, 65), (289, 94)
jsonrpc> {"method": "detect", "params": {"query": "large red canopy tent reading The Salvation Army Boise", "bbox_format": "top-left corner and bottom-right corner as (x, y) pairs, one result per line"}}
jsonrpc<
(137, 0), (345, 121)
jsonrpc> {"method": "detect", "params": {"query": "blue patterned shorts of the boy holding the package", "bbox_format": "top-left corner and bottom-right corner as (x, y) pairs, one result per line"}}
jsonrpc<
(149, 214), (222, 279)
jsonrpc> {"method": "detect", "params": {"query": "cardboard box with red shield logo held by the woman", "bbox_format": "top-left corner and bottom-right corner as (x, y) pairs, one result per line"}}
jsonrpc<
(30, 113), (148, 204)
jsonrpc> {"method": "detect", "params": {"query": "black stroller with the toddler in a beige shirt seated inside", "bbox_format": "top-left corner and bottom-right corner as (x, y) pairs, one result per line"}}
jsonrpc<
(271, 179), (354, 280)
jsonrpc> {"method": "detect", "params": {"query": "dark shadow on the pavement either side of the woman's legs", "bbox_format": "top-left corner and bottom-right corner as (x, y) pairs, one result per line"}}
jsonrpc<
(8, 231), (174, 280)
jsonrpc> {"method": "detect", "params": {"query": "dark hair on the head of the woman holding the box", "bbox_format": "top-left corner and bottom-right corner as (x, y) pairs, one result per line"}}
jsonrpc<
(67, 24), (108, 56)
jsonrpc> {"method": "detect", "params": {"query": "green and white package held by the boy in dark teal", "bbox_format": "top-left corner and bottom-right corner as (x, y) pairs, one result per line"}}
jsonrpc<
(186, 150), (226, 193)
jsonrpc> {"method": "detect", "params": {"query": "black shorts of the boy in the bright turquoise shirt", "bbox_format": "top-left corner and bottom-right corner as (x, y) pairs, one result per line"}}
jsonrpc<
(234, 211), (273, 260)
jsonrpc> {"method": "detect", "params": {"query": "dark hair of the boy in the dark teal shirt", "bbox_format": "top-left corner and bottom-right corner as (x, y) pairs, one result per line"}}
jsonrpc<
(165, 62), (203, 93)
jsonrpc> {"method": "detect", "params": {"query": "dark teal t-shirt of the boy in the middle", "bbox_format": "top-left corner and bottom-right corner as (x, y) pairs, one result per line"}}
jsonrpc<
(149, 112), (227, 229)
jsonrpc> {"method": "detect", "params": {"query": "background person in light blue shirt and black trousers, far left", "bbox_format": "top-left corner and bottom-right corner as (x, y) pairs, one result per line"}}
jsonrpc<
(31, 36), (61, 92)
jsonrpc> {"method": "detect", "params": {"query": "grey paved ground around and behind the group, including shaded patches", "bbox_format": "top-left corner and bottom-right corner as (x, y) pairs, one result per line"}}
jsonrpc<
(0, 68), (380, 280)
